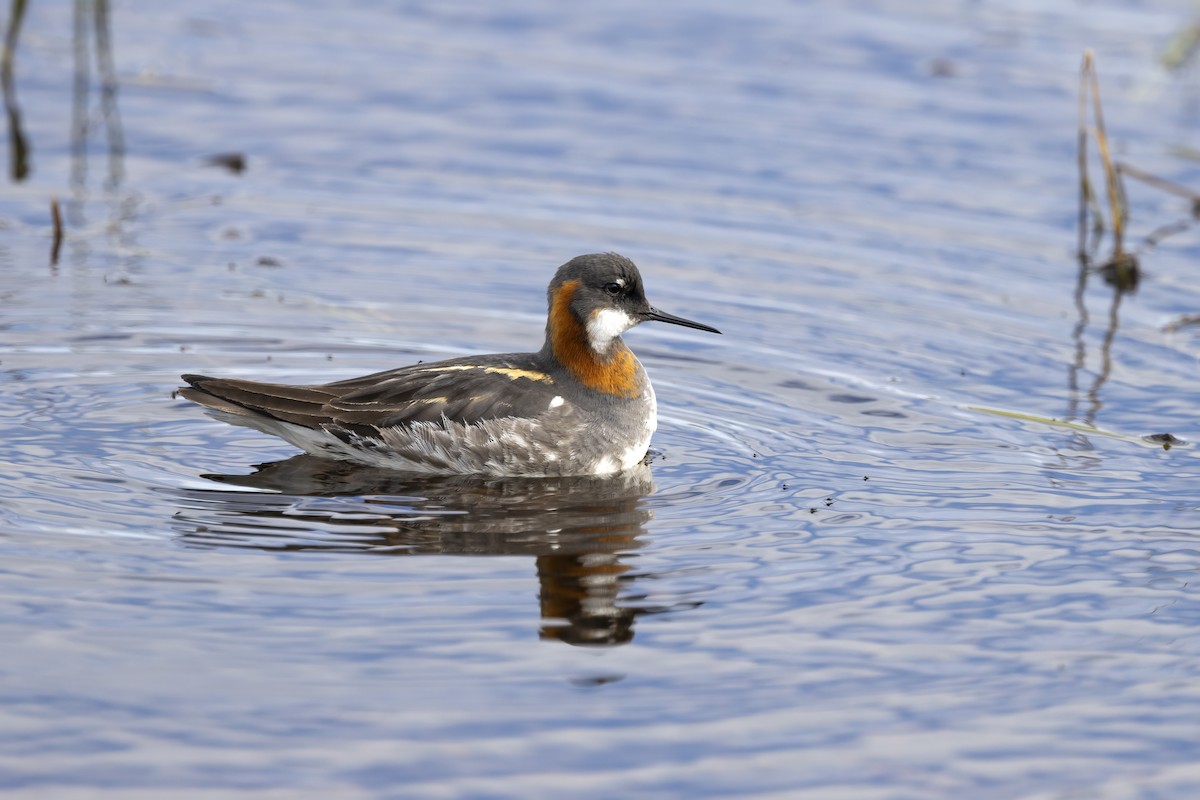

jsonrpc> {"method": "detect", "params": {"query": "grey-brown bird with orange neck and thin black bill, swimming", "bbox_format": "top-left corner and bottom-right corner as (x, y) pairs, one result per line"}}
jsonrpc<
(176, 253), (720, 477)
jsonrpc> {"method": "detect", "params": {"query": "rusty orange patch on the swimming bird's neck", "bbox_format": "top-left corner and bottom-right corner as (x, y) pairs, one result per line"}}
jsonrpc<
(550, 281), (640, 397)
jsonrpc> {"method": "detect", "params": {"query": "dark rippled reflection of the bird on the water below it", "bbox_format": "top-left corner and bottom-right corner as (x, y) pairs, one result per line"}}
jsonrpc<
(176, 455), (667, 645)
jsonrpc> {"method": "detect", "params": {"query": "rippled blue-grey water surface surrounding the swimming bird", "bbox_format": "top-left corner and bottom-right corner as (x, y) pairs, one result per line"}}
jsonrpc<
(0, 0), (1200, 799)
